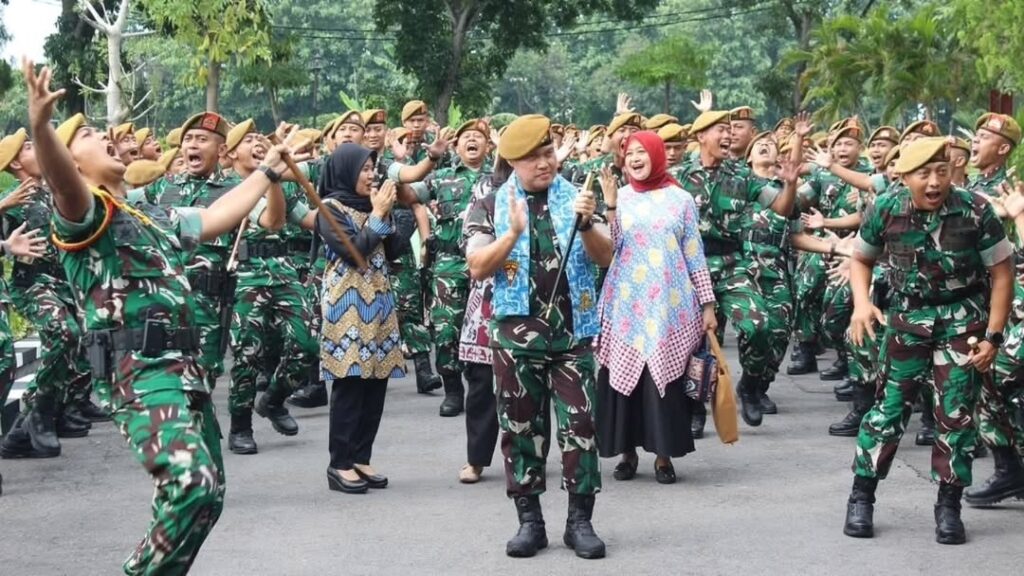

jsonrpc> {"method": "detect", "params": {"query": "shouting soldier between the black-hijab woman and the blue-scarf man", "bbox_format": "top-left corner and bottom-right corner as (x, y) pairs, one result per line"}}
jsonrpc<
(414, 120), (490, 417)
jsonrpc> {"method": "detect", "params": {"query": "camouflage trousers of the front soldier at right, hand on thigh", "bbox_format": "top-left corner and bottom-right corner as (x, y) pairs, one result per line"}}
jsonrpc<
(853, 320), (982, 486)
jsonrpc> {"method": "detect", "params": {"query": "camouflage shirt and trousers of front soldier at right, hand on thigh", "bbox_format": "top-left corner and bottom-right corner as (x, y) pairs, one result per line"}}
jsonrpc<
(853, 188), (1011, 486)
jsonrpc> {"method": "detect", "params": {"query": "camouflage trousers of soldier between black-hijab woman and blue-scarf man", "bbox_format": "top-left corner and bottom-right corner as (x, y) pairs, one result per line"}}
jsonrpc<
(430, 255), (469, 374)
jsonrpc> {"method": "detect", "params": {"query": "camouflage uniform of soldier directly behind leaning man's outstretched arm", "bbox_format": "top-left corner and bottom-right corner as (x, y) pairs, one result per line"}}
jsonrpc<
(144, 170), (242, 389)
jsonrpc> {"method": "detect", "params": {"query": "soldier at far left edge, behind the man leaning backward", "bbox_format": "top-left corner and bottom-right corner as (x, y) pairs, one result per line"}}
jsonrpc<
(0, 129), (97, 458)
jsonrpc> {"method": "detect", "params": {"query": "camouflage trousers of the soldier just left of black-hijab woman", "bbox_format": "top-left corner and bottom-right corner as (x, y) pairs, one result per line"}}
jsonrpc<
(227, 282), (319, 409)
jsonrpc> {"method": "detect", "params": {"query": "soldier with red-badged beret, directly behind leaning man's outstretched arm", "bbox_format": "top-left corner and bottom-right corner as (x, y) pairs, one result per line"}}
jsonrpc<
(144, 114), (240, 388)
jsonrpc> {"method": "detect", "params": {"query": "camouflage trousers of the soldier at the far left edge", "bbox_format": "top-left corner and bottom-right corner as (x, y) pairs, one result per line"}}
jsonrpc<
(12, 276), (92, 414)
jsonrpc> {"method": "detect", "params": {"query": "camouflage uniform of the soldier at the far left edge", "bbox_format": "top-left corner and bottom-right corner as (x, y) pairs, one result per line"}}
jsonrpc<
(4, 179), (91, 414)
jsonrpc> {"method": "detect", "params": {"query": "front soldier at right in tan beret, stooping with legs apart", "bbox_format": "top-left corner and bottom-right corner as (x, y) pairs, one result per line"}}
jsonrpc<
(844, 138), (1014, 544)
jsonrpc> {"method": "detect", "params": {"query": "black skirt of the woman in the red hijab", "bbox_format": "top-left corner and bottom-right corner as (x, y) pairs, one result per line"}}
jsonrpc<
(597, 368), (693, 458)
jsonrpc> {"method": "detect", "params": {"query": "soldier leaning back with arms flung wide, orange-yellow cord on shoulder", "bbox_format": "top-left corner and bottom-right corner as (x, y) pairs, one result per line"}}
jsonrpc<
(20, 61), (284, 575)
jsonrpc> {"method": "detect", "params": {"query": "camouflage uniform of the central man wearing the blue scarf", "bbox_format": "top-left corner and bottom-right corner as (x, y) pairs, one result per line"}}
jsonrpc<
(465, 188), (601, 498)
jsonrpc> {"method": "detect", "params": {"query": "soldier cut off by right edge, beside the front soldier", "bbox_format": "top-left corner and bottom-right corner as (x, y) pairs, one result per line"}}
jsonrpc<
(965, 114), (1024, 505)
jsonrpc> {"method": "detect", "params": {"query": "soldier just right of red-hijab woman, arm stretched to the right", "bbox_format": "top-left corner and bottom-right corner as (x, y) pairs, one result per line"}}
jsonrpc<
(679, 111), (795, 426)
